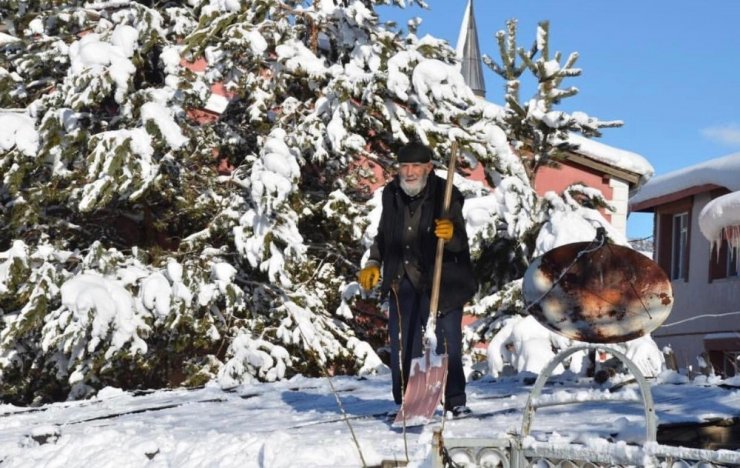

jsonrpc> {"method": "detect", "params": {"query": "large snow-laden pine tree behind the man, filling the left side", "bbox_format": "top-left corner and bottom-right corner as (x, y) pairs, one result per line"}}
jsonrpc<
(0, 0), (527, 403)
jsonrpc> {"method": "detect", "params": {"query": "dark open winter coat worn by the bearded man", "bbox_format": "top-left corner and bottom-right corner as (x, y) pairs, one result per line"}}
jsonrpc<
(370, 173), (478, 313)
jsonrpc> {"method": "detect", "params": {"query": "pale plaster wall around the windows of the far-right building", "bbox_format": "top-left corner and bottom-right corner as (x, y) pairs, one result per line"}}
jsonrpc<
(653, 193), (740, 368)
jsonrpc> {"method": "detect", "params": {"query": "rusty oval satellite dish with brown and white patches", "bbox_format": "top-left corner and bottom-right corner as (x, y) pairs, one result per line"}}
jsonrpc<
(522, 232), (673, 343)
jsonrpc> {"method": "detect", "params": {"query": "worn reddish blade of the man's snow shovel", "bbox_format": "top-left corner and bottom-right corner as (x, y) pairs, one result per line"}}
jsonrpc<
(393, 348), (448, 427)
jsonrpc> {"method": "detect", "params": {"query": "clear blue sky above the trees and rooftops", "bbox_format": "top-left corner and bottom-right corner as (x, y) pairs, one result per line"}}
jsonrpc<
(378, 0), (740, 238)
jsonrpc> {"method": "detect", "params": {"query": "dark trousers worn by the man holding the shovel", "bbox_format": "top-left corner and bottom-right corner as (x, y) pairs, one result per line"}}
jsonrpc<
(388, 276), (466, 409)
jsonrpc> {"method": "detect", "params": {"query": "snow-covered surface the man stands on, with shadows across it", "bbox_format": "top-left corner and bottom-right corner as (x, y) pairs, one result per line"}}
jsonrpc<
(0, 371), (740, 468)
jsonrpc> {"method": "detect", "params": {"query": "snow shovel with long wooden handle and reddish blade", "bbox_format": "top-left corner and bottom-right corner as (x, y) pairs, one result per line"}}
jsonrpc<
(393, 141), (457, 427)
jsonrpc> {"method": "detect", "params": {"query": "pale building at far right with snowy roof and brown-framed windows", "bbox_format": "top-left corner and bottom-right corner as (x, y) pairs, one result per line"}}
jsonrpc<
(630, 153), (740, 376)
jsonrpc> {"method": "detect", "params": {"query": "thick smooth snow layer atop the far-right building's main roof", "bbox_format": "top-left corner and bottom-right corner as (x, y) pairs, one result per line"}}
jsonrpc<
(630, 153), (740, 208)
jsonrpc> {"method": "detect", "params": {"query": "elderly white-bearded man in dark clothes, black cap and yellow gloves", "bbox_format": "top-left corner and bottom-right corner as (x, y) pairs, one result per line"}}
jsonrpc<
(359, 143), (477, 416)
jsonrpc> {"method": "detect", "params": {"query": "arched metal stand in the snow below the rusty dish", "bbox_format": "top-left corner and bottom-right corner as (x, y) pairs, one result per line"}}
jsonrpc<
(521, 343), (657, 442)
